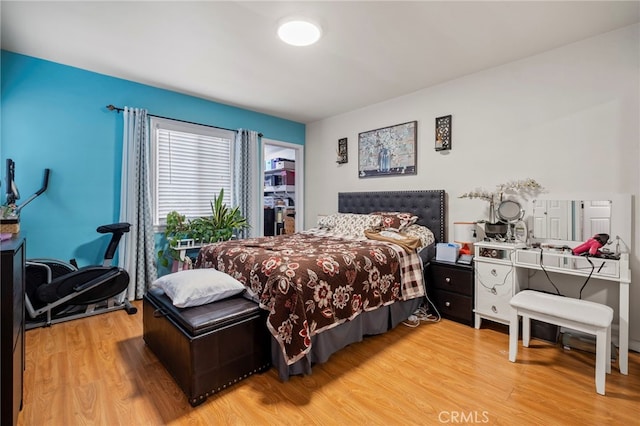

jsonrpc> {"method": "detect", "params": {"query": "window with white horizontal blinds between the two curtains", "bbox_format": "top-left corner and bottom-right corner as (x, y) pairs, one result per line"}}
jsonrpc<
(151, 117), (235, 226)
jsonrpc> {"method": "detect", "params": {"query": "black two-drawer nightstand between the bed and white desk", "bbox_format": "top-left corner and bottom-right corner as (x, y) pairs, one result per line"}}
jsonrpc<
(427, 260), (475, 326)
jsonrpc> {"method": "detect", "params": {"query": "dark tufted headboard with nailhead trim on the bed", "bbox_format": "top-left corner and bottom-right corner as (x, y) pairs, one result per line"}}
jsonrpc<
(338, 189), (447, 242)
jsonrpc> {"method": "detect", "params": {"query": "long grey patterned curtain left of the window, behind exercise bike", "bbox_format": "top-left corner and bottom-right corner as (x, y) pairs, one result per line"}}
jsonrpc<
(119, 107), (158, 300)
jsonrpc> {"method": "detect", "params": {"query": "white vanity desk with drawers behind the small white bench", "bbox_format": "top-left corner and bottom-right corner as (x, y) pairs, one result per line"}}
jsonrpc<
(475, 243), (631, 374)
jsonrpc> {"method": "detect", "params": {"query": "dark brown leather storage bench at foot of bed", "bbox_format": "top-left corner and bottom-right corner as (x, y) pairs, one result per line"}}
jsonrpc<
(143, 289), (271, 406)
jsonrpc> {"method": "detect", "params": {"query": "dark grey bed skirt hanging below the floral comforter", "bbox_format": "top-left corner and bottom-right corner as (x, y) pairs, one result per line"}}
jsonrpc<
(271, 297), (422, 381)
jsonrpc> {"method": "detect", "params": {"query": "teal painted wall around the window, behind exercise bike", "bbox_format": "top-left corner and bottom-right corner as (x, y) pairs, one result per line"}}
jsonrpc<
(0, 50), (305, 265)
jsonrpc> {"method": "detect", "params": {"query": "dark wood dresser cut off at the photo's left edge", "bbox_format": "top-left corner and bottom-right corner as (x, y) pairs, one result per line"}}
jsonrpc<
(0, 237), (25, 426)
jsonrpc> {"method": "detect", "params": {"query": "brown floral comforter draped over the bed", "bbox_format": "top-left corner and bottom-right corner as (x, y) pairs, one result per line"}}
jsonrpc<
(196, 233), (424, 364)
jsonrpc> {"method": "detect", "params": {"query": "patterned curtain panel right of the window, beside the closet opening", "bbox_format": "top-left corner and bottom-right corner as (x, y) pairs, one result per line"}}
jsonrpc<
(231, 129), (262, 238)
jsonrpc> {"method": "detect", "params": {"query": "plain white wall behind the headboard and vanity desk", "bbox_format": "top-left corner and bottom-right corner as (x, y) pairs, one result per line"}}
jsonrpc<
(305, 24), (640, 341)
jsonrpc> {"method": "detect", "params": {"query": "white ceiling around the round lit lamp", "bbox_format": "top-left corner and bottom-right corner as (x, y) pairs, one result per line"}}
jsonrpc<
(0, 0), (640, 123)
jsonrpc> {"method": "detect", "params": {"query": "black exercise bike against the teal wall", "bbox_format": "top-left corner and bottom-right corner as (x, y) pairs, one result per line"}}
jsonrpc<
(7, 159), (137, 329)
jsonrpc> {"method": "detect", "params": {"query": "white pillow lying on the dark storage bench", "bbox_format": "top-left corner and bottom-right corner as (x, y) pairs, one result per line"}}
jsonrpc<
(151, 269), (245, 308)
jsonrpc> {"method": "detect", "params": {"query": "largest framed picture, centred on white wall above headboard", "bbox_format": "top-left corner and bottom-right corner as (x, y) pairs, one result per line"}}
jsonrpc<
(358, 121), (418, 178)
